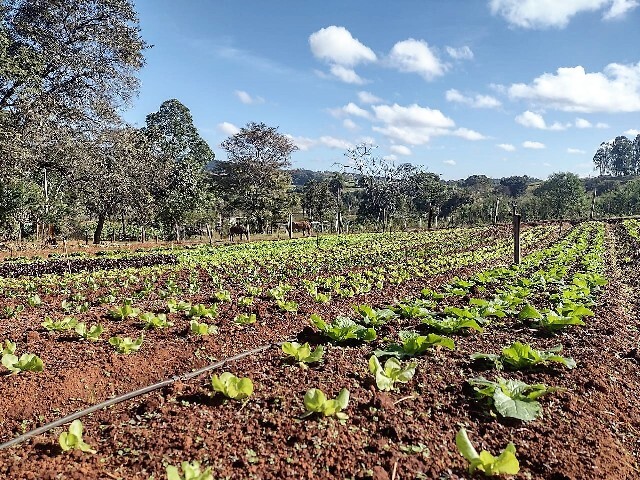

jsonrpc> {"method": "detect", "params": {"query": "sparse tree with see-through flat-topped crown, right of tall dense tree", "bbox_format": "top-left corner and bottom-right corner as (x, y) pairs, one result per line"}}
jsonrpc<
(215, 122), (298, 231)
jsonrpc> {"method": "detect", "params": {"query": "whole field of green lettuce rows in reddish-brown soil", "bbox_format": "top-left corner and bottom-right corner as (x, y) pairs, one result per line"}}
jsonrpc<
(0, 220), (640, 480)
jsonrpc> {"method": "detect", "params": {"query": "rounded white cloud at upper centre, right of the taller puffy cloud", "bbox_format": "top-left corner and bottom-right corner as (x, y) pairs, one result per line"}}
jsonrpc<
(389, 38), (446, 80)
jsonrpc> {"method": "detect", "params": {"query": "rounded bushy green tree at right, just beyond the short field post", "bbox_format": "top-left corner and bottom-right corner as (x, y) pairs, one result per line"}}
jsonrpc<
(534, 172), (588, 219)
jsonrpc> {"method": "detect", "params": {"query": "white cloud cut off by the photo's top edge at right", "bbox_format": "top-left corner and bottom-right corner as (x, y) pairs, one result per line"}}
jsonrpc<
(489, 0), (638, 28)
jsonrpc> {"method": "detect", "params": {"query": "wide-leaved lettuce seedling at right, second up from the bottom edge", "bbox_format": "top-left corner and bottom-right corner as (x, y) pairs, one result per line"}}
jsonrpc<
(467, 377), (559, 422)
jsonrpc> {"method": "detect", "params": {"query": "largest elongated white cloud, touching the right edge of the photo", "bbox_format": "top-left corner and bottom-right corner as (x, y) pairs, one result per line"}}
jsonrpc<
(508, 62), (640, 113)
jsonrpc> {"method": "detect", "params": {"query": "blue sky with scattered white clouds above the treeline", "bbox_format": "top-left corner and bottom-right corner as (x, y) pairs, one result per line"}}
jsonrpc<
(125, 0), (640, 179)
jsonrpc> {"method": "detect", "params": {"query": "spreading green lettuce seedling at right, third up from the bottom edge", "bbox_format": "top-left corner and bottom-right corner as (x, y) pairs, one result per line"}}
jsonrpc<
(471, 342), (576, 370)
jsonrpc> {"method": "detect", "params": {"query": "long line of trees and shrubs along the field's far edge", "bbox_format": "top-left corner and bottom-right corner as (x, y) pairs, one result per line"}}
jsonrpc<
(0, 0), (640, 243)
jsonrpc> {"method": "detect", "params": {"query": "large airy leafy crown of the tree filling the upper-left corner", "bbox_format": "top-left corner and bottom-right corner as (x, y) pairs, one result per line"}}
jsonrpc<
(0, 0), (147, 171)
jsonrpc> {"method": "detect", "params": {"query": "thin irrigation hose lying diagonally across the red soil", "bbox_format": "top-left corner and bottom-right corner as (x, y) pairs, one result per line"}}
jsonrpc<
(0, 340), (291, 450)
